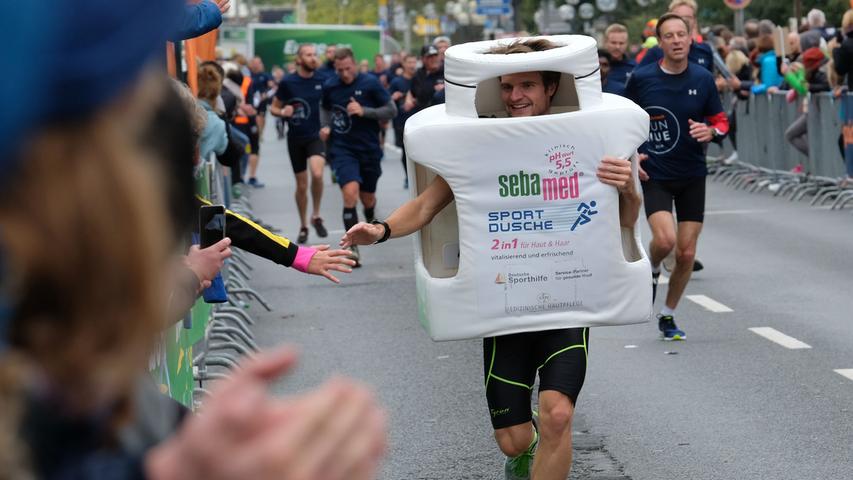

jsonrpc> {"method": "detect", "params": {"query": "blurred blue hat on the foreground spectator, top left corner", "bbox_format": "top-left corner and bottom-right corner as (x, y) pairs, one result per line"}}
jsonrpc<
(0, 0), (186, 183)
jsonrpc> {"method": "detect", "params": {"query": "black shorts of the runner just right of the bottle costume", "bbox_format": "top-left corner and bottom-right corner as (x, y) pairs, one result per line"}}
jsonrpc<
(642, 177), (705, 223)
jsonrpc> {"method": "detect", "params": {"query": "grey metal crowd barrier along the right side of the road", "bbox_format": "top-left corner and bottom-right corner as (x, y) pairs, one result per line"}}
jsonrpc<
(709, 92), (853, 209)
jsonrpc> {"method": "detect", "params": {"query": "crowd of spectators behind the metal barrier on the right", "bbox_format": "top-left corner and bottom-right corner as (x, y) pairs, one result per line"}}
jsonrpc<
(599, 0), (853, 184)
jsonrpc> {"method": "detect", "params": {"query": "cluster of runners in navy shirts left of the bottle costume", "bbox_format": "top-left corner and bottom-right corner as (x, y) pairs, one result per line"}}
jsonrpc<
(270, 41), (449, 266)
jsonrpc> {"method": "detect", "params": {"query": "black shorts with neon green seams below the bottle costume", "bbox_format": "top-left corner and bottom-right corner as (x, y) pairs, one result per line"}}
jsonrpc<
(483, 328), (589, 430)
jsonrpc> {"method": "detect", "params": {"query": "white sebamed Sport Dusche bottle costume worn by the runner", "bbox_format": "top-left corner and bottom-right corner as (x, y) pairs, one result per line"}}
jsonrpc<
(405, 35), (652, 340)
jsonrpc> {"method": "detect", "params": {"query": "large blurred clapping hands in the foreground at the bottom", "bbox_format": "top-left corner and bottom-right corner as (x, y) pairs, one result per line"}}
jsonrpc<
(145, 348), (386, 480)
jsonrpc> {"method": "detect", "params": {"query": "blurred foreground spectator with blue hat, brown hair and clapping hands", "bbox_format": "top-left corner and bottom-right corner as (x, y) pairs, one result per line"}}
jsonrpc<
(0, 0), (385, 480)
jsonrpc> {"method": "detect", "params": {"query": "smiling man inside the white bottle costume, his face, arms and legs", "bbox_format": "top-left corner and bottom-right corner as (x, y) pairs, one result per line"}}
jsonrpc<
(341, 39), (642, 480)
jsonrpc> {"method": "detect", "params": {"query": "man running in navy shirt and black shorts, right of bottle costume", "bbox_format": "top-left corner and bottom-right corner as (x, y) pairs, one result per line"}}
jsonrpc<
(625, 13), (729, 340)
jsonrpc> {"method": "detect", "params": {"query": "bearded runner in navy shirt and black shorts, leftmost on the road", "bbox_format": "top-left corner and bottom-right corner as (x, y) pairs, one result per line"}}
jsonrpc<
(270, 43), (328, 243)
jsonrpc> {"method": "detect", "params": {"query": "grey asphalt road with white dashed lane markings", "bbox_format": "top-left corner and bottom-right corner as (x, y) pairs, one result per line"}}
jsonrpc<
(240, 127), (853, 480)
